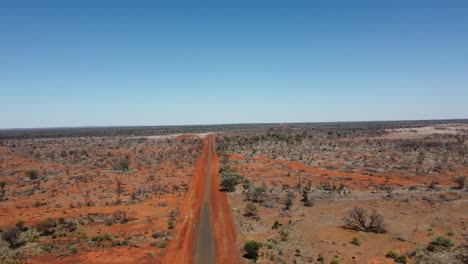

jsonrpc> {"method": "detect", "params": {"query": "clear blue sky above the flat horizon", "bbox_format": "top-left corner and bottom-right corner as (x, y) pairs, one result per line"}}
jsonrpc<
(0, 0), (468, 128)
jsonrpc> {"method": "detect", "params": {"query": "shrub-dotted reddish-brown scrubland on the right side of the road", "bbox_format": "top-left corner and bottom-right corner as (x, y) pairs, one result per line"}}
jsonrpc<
(217, 124), (468, 263)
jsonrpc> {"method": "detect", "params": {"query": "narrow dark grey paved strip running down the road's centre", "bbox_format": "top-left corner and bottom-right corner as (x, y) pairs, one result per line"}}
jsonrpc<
(195, 141), (216, 264)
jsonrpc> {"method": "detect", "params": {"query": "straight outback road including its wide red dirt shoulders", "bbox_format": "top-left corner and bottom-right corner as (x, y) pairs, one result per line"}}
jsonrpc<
(163, 135), (240, 264)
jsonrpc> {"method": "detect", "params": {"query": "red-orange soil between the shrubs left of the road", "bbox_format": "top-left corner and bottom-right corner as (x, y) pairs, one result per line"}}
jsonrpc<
(0, 138), (201, 263)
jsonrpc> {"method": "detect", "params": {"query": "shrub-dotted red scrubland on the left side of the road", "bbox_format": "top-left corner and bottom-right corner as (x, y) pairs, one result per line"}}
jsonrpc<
(0, 136), (202, 263)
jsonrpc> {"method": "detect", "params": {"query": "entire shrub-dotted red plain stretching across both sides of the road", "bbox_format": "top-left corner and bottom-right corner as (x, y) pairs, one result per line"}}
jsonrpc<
(0, 120), (468, 264)
